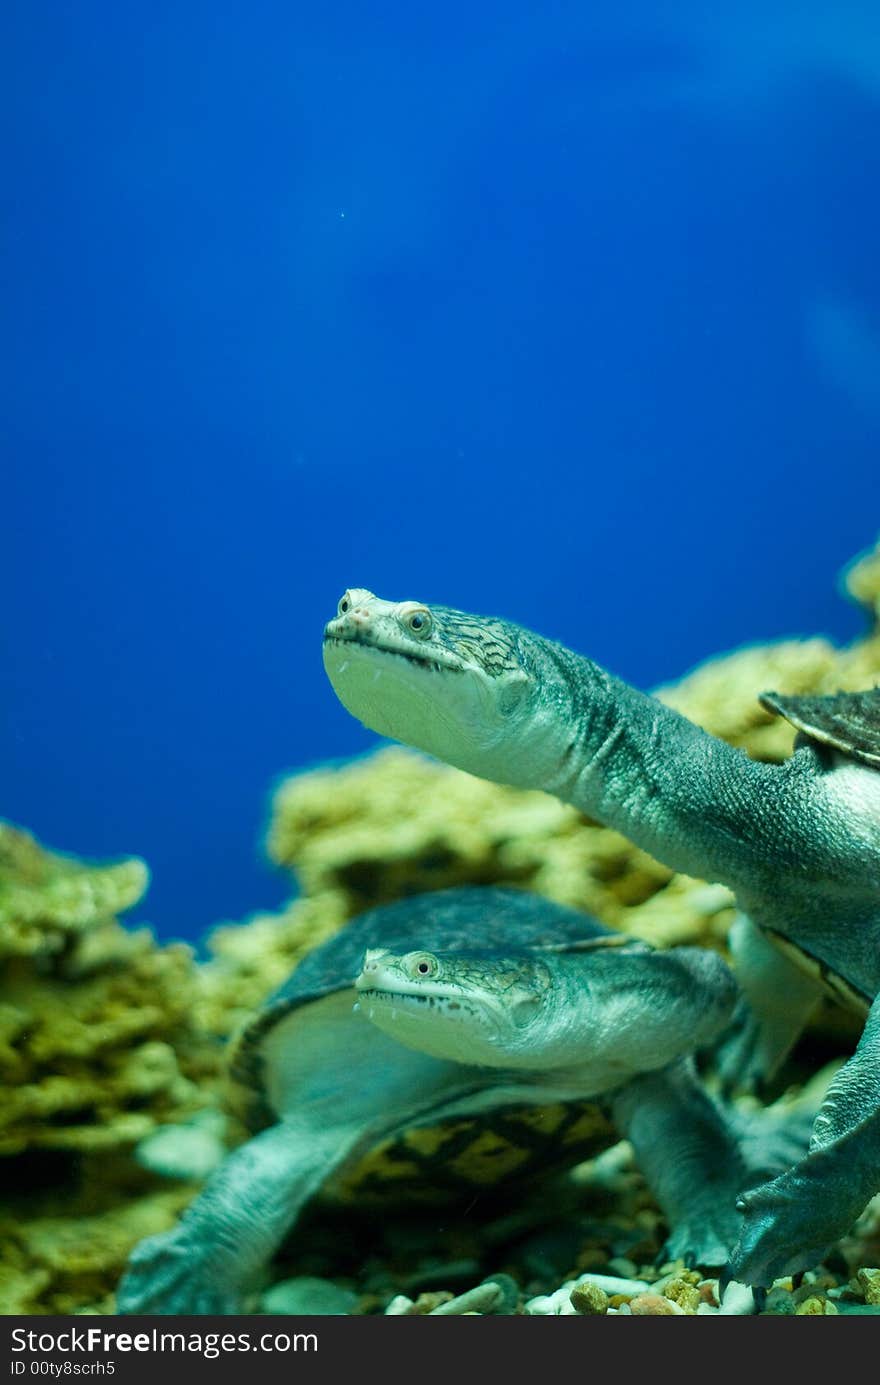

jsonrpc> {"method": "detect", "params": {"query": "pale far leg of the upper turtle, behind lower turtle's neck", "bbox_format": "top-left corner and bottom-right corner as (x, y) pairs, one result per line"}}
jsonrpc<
(712, 914), (822, 1094)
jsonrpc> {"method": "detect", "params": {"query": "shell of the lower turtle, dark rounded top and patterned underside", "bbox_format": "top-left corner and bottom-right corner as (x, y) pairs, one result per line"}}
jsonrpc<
(229, 886), (626, 1205)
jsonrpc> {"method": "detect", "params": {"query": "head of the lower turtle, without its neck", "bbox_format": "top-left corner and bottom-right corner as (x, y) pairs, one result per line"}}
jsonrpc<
(355, 947), (552, 1068)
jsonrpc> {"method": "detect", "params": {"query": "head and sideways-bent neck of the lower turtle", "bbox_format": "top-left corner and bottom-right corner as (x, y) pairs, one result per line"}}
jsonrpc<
(355, 933), (737, 1074)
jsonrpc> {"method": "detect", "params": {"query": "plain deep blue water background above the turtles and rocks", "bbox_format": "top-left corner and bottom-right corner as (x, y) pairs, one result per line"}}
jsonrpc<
(0, 0), (880, 938)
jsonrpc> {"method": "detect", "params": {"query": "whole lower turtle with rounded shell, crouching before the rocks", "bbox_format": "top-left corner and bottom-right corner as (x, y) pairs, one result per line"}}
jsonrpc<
(116, 885), (791, 1314)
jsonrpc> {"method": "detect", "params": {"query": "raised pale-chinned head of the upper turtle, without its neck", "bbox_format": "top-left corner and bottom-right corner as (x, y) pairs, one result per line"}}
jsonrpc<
(324, 587), (548, 784)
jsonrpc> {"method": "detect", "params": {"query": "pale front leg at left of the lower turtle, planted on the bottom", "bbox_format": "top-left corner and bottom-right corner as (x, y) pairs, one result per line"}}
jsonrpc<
(116, 1120), (353, 1314)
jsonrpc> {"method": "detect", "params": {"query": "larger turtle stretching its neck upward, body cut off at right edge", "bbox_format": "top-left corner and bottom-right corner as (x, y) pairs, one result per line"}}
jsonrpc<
(323, 587), (880, 1288)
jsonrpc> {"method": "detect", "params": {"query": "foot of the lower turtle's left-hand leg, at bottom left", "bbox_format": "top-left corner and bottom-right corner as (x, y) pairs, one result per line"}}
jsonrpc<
(116, 1227), (243, 1316)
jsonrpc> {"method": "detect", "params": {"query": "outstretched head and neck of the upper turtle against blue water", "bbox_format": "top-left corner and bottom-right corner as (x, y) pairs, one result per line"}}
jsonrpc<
(324, 589), (809, 888)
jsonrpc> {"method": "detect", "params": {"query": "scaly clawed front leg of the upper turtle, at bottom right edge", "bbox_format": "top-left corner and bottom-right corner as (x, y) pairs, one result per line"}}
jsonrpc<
(725, 999), (880, 1287)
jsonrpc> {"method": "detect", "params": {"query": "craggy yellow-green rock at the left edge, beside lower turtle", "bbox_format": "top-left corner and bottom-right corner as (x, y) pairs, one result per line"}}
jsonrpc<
(0, 823), (220, 1313)
